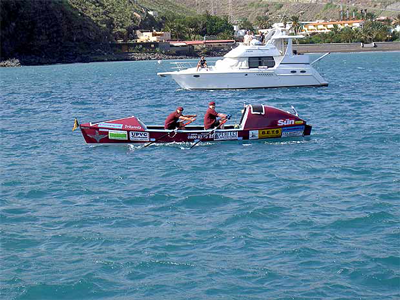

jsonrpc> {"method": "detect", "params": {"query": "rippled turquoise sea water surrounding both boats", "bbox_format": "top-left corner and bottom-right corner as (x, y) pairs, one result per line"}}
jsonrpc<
(0, 52), (400, 300)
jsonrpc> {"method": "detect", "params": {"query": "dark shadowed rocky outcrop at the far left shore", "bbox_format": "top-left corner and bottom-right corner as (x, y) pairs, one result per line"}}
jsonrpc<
(0, 0), (112, 65)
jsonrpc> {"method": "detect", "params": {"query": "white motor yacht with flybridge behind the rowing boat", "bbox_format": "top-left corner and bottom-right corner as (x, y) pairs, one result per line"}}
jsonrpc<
(157, 28), (329, 90)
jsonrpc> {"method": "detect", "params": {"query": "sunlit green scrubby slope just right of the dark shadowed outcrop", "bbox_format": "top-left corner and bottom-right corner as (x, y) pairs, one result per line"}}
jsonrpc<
(69, 0), (233, 41)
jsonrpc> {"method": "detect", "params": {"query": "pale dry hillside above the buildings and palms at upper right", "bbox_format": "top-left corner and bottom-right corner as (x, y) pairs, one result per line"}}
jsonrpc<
(176, 0), (400, 22)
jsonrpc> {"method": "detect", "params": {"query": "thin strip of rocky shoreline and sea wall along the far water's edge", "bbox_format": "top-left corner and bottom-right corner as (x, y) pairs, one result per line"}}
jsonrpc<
(0, 42), (400, 67)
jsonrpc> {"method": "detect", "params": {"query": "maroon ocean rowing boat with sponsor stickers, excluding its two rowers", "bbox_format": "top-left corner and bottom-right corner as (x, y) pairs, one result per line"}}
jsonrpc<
(78, 104), (312, 144)
